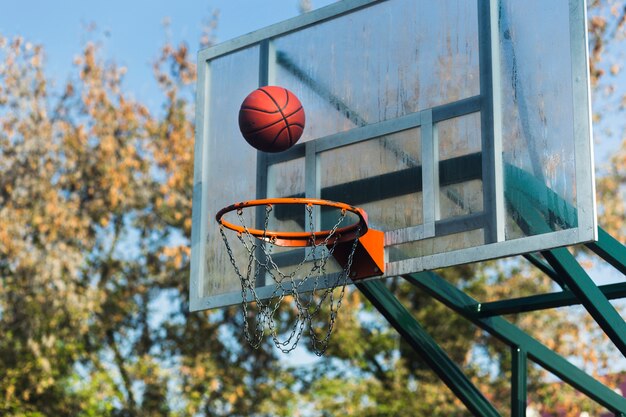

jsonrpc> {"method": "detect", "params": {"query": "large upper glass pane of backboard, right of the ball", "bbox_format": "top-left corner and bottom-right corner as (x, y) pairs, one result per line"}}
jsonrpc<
(273, 0), (480, 141)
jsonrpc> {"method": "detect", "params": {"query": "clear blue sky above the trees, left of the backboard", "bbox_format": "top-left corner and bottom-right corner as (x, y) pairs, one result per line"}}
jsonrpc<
(0, 0), (334, 104)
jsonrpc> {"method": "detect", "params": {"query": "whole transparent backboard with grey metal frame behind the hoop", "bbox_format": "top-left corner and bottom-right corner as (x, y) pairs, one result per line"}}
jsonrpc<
(190, 0), (597, 310)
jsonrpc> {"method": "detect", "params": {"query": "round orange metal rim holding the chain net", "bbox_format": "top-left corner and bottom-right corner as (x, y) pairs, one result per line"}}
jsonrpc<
(215, 198), (368, 247)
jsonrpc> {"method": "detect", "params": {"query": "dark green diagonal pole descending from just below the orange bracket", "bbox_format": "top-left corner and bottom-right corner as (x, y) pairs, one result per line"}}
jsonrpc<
(356, 281), (500, 417)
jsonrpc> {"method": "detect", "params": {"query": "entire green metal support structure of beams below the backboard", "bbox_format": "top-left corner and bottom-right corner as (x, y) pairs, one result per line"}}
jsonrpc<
(356, 223), (626, 417)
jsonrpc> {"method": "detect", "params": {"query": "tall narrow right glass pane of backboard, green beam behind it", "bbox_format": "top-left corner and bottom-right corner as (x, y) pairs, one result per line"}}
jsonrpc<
(499, 0), (578, 240)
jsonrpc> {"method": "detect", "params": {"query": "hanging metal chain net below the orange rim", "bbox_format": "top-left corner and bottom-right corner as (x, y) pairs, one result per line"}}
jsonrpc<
(220, 204), (360, 356)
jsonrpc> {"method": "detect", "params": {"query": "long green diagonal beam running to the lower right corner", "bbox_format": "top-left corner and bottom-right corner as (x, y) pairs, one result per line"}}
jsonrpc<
(403, 272), (626, 415)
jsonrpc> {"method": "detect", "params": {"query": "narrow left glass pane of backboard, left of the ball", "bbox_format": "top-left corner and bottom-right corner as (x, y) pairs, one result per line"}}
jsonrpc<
(200, 47), (259, 297)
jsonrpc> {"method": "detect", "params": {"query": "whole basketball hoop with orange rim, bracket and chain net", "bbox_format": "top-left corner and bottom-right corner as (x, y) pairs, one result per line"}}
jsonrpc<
(215, 198), (384, 356)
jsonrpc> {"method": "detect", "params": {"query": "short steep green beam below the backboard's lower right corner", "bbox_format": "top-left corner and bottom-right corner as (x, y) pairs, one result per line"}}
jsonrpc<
(543, 248), (626, 356)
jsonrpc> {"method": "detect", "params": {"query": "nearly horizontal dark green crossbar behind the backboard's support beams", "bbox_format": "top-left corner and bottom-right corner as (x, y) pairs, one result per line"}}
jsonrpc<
(476, 283), (626, 317)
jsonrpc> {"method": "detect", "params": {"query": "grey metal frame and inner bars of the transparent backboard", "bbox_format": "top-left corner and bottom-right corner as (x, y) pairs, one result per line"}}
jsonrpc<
(190, 0), (597, 311)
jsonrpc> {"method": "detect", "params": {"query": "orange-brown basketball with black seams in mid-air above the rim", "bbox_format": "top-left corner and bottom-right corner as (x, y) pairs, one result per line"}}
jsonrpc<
(239, 86), (305, 152)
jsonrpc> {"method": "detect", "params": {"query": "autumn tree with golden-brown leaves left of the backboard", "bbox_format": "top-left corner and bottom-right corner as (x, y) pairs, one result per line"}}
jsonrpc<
(0, 24), (294, 416)
